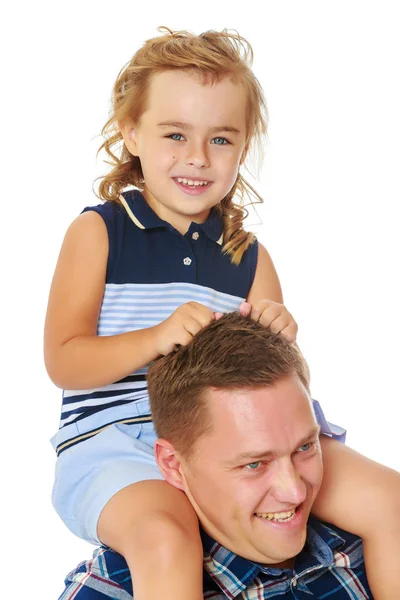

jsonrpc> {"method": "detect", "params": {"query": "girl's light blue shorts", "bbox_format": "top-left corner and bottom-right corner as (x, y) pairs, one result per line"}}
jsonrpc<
(52, 399), (346, 545)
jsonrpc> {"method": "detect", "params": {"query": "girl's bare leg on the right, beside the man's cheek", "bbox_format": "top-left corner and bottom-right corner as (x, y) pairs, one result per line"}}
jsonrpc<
(313, 435), (400, 600)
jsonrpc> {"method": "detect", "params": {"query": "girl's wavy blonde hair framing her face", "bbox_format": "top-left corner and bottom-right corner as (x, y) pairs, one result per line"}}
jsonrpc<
(99, 27), (267, 264)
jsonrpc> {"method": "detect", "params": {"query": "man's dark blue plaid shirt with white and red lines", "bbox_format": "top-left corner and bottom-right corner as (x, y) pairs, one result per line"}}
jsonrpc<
(59, 518), (373, 600)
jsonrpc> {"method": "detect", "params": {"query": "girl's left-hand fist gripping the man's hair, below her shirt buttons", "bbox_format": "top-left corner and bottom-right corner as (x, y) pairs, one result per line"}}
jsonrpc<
(153, 302), (217, 356)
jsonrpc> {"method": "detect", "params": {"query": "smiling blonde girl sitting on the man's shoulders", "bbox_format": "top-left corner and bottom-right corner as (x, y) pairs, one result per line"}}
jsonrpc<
(45, 30), (400, 600)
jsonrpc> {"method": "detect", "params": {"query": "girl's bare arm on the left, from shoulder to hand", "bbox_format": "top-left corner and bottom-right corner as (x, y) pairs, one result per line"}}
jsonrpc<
(44, 211), (214, 389)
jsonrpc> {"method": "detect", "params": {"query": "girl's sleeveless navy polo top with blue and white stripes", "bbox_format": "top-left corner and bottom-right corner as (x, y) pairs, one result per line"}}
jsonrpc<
(52, 191), (257, 454)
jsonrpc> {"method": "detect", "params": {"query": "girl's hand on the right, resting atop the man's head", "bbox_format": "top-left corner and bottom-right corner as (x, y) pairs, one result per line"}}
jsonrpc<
(239, 300), (298, 342)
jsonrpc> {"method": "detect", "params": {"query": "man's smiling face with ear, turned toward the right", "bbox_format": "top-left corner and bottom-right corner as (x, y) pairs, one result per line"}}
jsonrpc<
(181, 375), (322, 567)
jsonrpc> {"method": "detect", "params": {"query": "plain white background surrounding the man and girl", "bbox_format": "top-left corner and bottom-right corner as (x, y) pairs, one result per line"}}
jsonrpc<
(0, 0), (400, 599)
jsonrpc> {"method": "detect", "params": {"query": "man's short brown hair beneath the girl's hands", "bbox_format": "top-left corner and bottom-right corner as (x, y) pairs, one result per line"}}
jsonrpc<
(147, 313), (309, 458)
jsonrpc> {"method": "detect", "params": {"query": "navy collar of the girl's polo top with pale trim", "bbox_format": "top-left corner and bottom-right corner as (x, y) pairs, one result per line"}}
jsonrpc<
(120, 190), (223, 245)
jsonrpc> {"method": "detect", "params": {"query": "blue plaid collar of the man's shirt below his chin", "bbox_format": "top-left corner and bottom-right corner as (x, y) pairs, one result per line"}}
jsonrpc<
(202, 517), (346, 598)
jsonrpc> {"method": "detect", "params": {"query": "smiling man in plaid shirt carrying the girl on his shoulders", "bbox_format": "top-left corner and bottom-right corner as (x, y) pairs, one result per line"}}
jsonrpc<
(60, 313), (372, 600)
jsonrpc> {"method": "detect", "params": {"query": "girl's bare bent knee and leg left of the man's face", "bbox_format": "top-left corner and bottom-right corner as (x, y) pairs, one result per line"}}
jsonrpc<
(97, 480), (203, 600)
